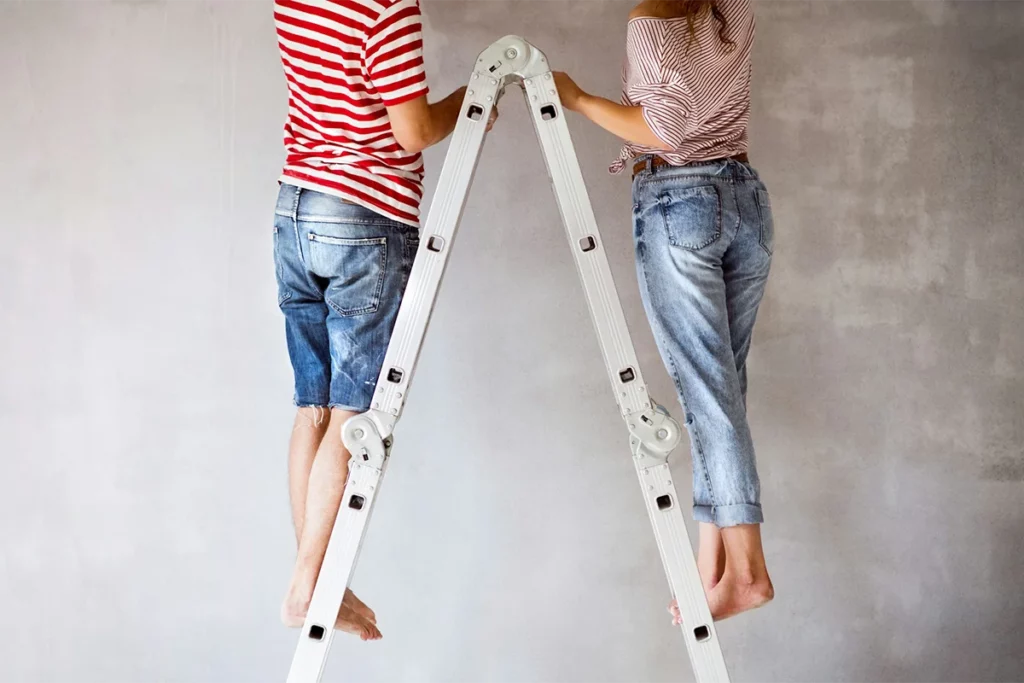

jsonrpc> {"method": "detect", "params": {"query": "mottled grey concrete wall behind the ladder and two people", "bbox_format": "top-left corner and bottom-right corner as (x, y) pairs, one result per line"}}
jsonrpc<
(0, 0), (1024, 683)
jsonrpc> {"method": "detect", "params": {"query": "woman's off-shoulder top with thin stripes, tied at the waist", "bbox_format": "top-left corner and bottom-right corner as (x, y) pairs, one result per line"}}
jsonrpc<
(611, 0), (754, 173)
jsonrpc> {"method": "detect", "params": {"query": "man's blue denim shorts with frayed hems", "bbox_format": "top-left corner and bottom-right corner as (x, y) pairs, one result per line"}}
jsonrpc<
(273, 183), (419, 413)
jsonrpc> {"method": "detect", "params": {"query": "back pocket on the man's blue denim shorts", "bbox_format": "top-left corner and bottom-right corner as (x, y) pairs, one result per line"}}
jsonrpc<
(308, 232), (387, 317)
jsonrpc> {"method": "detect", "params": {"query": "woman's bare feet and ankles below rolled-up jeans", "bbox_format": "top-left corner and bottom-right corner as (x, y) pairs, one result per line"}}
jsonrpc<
(669, 524), (775, 626)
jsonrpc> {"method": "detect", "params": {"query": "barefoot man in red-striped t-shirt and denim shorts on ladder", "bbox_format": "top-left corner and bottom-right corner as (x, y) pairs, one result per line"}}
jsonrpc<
(274, 0), (493, 640)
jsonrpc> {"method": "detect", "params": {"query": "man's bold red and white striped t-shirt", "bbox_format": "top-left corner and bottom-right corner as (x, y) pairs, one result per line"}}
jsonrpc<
(274, 0), (427, 225)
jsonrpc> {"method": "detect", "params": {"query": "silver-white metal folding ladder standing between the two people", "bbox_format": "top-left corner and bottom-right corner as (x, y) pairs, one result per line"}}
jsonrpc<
(288, 36), (729, 683)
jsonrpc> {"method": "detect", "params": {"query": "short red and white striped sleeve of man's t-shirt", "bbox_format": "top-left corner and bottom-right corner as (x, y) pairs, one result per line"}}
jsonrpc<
(365, 0), (428, 106)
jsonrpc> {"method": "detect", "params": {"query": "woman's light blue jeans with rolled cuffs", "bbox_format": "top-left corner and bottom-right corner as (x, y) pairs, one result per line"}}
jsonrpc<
(633, 161), (773, 527)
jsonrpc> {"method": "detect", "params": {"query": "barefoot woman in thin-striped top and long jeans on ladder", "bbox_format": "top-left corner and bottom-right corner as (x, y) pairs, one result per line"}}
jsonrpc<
(556, 0), (774, 623)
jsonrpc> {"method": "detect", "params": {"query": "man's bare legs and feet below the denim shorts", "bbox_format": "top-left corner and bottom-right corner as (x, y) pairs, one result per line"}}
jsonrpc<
(282, 408), (381, 640)
